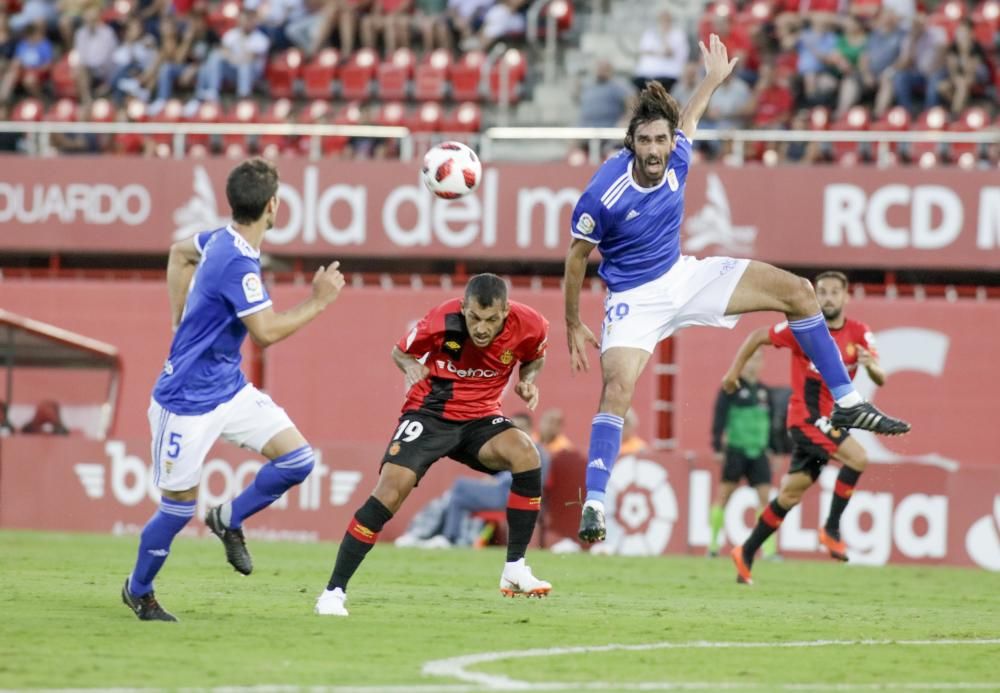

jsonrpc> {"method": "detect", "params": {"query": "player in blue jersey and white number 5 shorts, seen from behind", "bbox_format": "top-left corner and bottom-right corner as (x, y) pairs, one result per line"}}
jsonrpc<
(122, 159), (344, 621)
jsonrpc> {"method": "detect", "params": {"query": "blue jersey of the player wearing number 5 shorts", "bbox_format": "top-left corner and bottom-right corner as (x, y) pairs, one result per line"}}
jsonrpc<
(153, 226), (271, 415)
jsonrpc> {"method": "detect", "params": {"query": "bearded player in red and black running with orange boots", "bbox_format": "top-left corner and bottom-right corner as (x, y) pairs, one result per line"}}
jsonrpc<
(722, 272), (885, 584)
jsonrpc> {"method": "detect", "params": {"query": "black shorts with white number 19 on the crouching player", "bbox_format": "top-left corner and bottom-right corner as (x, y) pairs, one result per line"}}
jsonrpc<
(382, 411), (515, 484)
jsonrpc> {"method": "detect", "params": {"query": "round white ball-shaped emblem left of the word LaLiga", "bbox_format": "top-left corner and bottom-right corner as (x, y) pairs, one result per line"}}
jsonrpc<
(606, 456), (678, 556)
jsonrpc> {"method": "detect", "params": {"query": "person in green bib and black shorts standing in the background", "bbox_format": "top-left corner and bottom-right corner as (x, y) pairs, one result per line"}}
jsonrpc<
(708, 351), (777, 557)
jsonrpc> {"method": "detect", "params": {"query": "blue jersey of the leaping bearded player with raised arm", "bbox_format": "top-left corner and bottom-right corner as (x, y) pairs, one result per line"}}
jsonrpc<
(570, 130), (691, 291)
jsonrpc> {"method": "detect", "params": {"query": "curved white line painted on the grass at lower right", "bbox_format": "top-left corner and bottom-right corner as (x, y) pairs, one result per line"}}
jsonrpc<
(422, 638), (1000, 690)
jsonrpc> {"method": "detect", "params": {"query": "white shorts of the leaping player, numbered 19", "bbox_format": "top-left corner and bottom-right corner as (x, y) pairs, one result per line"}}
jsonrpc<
(601, 255), (750, 354)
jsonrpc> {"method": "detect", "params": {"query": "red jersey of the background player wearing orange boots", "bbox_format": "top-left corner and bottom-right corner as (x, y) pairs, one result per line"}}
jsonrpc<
(768, 319), (878, 426)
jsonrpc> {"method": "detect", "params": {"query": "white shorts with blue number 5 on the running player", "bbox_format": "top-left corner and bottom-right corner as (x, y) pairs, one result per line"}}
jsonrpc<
(149, 383), (294, 491)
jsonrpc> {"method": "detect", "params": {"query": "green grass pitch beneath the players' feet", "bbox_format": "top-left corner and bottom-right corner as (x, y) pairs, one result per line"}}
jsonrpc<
(0, 531), (1000, 691)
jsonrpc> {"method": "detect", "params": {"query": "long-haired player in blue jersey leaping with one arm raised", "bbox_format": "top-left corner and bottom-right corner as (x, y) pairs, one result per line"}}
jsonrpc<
(564, 34), (910, 542)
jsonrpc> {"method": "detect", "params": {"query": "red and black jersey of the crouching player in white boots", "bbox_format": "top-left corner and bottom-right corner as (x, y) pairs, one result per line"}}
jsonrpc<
(396, 298), (549, 421)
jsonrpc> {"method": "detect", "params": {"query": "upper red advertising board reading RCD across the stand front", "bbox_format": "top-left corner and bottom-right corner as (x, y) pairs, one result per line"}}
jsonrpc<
(0, 157), (1000, 269)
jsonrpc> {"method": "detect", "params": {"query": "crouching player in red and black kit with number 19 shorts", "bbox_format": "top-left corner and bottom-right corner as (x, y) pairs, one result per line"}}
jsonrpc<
(316, 274), (552, 616)
